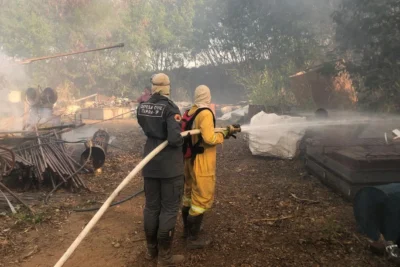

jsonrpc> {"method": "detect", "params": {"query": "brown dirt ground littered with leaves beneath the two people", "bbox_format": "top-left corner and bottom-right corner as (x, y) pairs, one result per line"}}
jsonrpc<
(0, 120), (391, 267)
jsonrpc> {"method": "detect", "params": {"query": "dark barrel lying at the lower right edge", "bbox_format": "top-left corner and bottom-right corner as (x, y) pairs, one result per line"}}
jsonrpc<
(353, 183), (400, 244)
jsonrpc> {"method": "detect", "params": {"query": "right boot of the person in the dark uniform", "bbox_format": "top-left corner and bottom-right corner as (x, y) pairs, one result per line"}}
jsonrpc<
(157, 230), (185, 267)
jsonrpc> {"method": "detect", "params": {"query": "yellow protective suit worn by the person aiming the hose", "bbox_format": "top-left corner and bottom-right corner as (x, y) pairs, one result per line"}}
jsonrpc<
(183, 87), (224, 216)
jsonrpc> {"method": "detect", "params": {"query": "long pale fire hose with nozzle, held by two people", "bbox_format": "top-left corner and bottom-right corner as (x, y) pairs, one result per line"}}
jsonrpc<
(54, 125), (241, 267)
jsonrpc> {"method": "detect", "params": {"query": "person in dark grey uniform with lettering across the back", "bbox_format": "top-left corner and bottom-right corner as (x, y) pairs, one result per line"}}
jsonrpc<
(137, 73), (184, 266)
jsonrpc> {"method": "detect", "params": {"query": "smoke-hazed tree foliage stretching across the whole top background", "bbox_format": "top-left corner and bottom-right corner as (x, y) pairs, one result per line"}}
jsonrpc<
(4, 0), (384, 112)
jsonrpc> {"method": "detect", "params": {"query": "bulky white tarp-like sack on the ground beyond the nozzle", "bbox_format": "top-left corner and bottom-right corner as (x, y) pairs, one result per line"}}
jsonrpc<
(249, 112), (306, 159)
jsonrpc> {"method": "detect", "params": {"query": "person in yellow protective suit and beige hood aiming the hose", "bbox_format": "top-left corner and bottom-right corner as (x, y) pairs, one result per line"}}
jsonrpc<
(182, 85), (238, 249)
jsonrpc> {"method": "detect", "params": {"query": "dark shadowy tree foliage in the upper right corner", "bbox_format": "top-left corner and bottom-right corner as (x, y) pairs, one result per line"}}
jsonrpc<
(333, 0), (400, 111)
